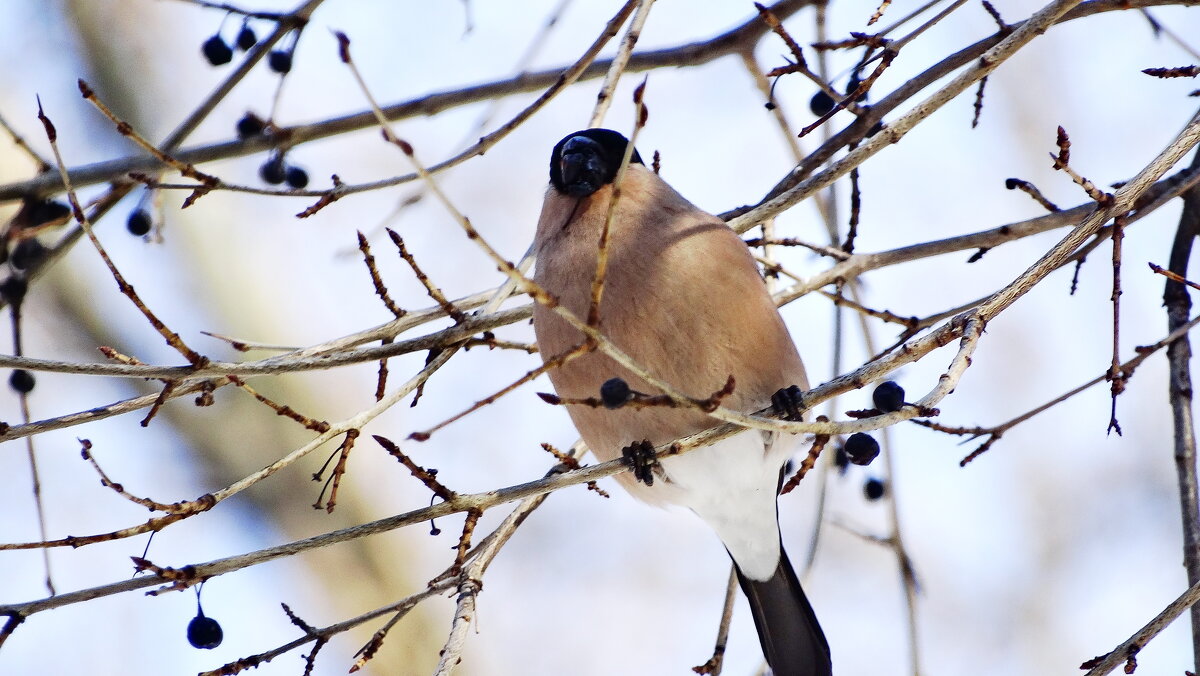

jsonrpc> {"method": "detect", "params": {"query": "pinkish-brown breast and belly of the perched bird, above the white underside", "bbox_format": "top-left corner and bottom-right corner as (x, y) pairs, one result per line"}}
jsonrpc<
(534, 166), (808, 468)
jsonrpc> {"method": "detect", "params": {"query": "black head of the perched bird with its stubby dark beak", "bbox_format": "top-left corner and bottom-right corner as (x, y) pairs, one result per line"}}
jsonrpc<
(550, 128), (642, 197)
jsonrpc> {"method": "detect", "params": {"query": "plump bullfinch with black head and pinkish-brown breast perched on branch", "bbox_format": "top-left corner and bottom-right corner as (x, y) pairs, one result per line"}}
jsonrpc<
(533, 128), (833, 676)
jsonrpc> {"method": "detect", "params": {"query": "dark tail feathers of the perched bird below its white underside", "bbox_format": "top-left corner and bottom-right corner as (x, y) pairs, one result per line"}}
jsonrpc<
(738, 548), (833, 676)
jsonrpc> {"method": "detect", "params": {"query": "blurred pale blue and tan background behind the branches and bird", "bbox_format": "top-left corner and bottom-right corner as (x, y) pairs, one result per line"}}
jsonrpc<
(0, 0), (1200, 675)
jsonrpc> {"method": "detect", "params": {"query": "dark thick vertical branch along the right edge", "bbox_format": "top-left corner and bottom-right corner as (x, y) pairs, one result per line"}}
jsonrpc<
(1163, 145), (1200, 666)
